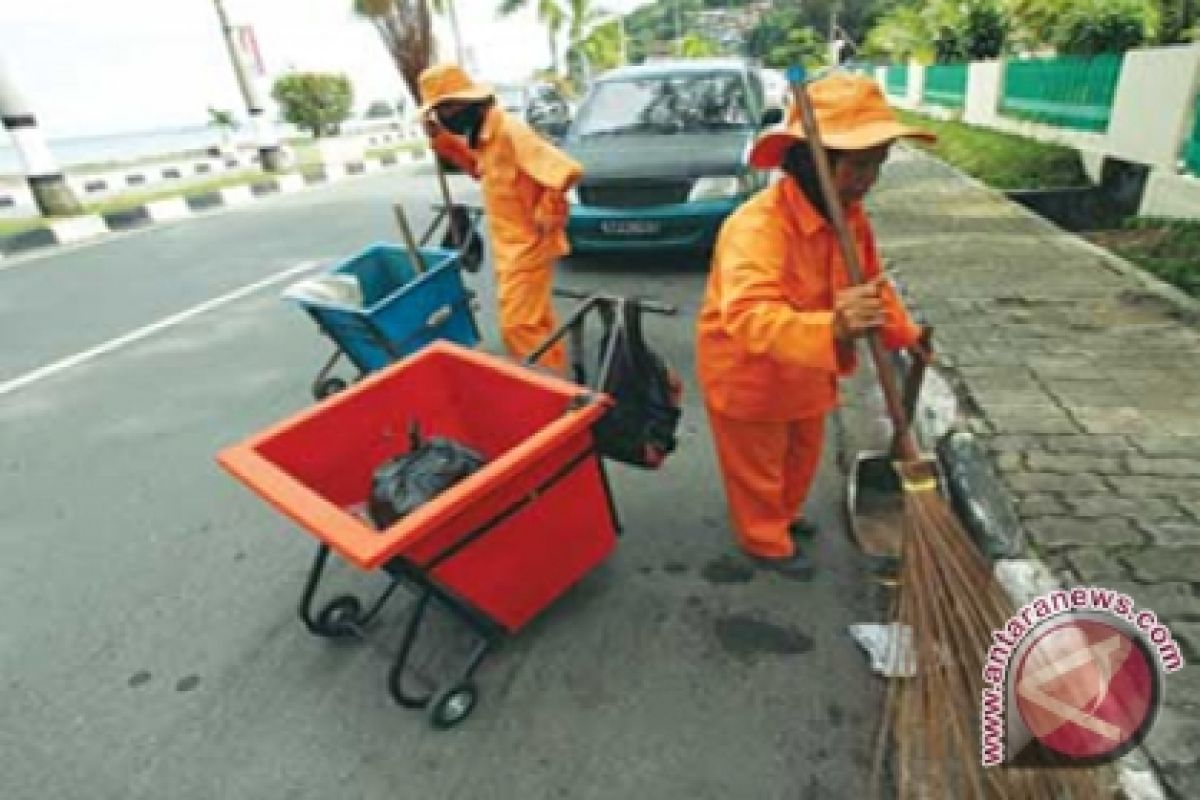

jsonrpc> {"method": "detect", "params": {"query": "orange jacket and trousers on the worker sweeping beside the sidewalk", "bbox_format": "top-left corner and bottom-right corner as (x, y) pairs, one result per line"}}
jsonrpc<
(696, 178), (920, 558)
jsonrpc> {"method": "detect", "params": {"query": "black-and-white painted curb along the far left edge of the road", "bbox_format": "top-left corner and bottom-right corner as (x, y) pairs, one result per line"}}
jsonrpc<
(0, 150), (428, 261)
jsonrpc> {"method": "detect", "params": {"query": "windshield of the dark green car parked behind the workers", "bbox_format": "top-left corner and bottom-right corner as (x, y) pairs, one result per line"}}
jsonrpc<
(575, 72), (754, 137)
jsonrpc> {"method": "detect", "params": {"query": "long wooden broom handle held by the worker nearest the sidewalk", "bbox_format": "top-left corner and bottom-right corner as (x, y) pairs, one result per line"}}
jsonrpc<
(787, 67), (920, 462)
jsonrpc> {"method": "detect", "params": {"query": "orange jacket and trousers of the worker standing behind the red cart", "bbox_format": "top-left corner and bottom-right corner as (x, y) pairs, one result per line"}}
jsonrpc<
(433, 107), (583, 373)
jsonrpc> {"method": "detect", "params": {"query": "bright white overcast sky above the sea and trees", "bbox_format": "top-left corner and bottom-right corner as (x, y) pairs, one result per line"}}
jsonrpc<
(0, 0), (646, 136)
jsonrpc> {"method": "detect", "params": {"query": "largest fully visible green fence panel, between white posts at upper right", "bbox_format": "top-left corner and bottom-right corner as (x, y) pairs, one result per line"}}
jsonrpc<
(1000, 53), (1123, 133)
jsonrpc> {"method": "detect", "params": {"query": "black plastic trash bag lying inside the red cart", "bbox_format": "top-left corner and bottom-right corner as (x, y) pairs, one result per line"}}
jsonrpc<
(367, 422), (485, 530)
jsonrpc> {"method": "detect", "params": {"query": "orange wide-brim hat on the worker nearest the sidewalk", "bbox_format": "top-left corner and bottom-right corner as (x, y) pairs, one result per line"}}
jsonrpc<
(750, 73), (937, 169)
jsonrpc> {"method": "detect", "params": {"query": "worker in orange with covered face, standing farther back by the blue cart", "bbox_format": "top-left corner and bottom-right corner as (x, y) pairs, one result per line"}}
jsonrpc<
(420, 65), (583, 373)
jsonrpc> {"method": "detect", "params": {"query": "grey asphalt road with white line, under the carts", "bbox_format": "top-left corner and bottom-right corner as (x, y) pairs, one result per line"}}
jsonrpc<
(0, 164), (881, 800)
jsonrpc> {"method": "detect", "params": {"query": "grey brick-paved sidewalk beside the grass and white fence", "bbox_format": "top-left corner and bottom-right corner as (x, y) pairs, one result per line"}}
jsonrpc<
(871, 151), (1200, 798)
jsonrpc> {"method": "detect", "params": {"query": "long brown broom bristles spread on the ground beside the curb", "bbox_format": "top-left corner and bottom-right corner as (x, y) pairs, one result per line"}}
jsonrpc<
(872, 482), (1114, 800)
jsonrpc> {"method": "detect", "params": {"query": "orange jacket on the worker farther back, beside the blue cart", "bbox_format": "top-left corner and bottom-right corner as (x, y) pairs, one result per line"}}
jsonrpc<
(433, 107), (583, 275)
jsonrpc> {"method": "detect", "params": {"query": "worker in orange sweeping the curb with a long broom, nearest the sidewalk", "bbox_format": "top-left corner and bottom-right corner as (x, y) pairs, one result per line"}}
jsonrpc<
(697, 73), (934, 578)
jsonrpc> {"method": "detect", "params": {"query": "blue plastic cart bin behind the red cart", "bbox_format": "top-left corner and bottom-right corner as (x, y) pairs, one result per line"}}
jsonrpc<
(298, 243), (479, 373)
